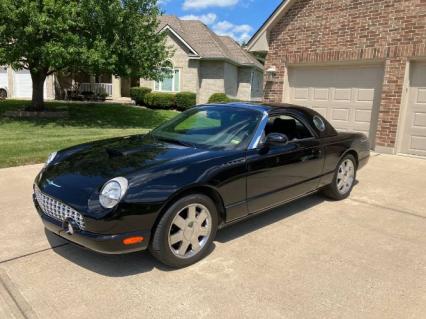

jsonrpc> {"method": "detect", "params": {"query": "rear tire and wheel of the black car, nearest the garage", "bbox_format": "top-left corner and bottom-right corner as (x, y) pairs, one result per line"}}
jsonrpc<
(323, 155), (357, 200)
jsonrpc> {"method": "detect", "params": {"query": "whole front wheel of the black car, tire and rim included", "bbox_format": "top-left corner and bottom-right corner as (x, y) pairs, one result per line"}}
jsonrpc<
(149, 194), (218, 268)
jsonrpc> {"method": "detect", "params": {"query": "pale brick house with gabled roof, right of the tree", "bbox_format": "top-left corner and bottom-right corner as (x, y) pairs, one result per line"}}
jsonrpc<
(140, 16), (263, 103)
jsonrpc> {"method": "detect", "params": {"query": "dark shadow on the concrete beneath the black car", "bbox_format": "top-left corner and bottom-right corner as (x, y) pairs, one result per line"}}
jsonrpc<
(46, 195), (325, 277)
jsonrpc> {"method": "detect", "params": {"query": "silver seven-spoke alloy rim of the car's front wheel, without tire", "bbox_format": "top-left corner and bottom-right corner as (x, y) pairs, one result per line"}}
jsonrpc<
(168, 204), (212, 259)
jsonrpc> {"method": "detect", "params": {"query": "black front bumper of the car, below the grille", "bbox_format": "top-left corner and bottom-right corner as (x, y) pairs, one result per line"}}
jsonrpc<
(34, 200), (151, 254)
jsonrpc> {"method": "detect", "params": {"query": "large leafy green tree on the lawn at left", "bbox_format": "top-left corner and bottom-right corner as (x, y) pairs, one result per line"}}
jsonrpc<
(0, 0), (171, 110)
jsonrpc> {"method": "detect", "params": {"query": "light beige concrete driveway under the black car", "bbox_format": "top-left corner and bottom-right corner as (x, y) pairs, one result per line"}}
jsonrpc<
(0, 155), (426, 319)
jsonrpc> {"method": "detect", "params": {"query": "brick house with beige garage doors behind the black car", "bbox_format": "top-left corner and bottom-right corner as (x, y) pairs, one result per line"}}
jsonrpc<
(247, 0), (426, 156)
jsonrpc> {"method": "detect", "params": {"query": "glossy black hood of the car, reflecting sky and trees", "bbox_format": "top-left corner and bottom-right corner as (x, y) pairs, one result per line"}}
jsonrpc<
(36, 135), (206, 212)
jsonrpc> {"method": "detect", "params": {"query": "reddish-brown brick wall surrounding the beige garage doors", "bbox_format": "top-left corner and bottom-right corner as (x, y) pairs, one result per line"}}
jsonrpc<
(264, 0), (426, 147)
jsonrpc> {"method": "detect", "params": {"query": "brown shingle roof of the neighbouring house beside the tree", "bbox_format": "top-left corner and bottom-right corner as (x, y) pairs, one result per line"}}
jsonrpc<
(159, 16), (263, 69)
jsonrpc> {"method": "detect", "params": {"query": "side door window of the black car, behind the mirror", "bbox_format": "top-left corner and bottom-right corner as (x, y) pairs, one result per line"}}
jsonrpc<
(265, 115), (312, 141)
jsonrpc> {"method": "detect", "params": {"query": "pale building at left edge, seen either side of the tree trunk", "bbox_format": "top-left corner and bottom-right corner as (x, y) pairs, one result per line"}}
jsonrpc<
(0, 66), (55, 100)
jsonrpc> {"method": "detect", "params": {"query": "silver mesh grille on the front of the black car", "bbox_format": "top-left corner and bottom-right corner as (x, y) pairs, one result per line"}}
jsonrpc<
(34, 186), (85, 230)
